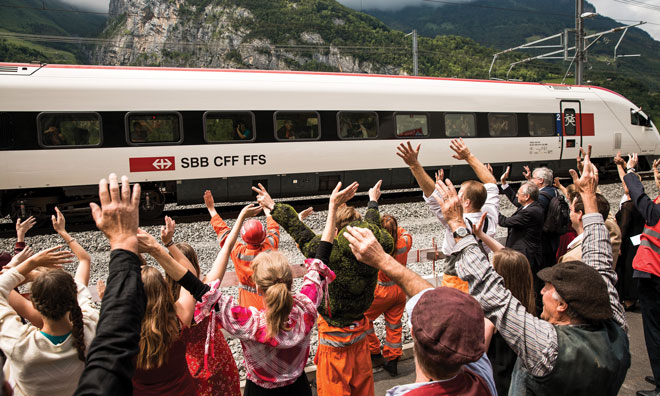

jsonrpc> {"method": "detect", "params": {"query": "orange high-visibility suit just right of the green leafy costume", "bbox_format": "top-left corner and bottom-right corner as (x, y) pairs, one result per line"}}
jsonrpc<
(364, 227), (412, 360)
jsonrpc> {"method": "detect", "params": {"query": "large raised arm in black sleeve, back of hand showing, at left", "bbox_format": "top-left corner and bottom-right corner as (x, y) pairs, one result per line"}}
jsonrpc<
(75, 174), (147, 396)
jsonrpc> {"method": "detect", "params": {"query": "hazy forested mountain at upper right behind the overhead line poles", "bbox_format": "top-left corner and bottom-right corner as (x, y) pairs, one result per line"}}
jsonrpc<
(365, 0), (660, 122)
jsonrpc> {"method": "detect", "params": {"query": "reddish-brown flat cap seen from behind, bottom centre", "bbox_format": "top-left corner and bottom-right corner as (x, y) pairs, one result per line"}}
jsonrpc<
(410, 287), (486, 365)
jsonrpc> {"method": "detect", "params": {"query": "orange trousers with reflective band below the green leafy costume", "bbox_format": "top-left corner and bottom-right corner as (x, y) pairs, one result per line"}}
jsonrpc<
(314, 315), (374, 396)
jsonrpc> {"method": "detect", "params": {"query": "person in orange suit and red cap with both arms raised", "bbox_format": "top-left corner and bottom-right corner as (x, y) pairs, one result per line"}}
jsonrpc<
(204, 190), (280, 309)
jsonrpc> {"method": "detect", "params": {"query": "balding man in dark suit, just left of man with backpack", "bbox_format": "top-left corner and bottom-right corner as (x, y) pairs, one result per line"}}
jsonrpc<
(498, 178), (545, 314)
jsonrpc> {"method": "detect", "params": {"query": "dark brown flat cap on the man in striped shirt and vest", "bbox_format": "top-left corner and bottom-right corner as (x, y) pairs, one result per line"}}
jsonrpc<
(537, 261), (612, 321)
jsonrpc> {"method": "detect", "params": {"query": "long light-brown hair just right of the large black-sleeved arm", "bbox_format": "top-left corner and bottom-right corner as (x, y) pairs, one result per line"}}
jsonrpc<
(137, 265), (180, 370)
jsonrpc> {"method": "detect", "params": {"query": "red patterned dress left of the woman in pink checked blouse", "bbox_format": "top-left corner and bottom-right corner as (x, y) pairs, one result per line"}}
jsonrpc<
(182, 316), (241, 396)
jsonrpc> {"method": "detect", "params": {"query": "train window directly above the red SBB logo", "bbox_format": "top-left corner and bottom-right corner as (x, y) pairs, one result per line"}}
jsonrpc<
(126, 113), (183, 144)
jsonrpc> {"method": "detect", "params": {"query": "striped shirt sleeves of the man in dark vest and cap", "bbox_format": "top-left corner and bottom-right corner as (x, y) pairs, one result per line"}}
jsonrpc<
(454, 213), (628, 377)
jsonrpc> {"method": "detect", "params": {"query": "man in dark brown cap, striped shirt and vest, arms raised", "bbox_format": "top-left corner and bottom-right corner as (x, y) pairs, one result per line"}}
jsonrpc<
(438, 149), (630, 396)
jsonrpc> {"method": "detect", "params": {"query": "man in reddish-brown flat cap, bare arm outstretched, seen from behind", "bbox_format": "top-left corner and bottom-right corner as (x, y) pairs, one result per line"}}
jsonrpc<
(344, 227), (497, 396)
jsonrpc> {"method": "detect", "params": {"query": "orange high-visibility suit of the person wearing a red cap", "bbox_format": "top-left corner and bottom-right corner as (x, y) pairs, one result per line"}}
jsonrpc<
(211, 215), (280, 309)
